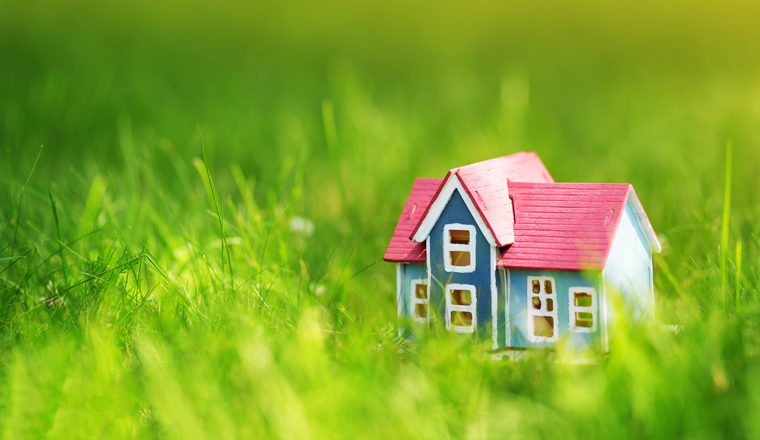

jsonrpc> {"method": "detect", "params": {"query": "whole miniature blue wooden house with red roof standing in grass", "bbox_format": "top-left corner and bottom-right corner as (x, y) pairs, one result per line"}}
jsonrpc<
(384, 153), (661, 351)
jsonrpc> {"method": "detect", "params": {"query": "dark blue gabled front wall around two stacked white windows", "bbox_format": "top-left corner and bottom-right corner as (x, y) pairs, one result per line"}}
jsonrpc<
(428, 191), (496, 339)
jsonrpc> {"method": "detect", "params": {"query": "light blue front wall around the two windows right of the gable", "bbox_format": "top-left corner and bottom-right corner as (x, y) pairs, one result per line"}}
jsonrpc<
(505, 270), (603, 350)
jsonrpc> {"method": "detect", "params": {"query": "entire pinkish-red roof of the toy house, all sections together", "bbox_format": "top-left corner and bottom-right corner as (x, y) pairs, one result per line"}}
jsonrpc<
(385, 153), (659, 271)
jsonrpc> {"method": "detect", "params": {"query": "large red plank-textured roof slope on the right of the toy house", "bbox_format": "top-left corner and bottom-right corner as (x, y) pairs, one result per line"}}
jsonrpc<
(497, 182), (633, 270)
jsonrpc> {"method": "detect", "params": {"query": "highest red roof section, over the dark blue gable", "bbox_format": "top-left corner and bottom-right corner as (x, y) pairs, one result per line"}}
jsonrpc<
(409, 152), (554, 247)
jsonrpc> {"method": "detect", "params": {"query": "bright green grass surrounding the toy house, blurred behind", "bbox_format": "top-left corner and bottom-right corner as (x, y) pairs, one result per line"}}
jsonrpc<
(0, 1), (760, 439)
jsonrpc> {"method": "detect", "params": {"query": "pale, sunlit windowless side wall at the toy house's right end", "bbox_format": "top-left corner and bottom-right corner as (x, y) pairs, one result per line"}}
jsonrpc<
(603, 201), (654, 322)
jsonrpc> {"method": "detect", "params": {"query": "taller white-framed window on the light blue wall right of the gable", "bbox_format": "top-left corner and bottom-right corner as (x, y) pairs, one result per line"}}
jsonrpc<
(528, 277), (559, 342)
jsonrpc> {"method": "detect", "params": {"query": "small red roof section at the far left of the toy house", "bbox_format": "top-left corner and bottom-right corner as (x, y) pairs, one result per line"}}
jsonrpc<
(383, 179), (443, 263)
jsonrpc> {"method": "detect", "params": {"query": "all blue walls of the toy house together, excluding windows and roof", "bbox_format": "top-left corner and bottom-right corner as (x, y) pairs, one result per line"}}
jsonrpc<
(398, 190), (654, 350)
